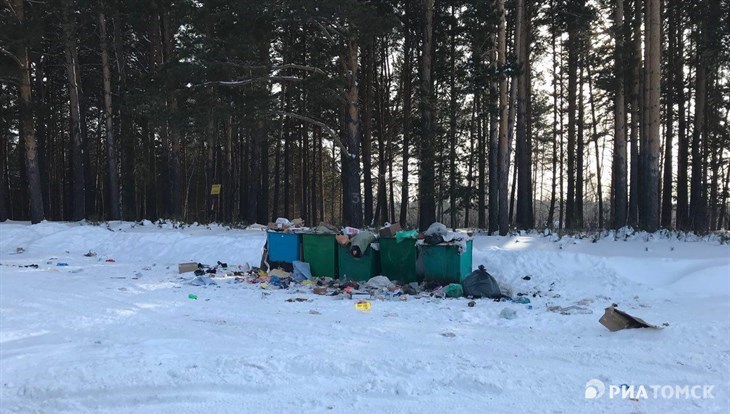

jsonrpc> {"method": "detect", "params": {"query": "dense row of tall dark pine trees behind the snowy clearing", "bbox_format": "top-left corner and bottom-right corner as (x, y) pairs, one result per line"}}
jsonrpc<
(0, 0), (730, 234)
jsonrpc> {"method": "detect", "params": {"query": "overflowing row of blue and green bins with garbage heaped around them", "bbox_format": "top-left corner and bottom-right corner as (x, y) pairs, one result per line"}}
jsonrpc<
(179, 218), (529, 306)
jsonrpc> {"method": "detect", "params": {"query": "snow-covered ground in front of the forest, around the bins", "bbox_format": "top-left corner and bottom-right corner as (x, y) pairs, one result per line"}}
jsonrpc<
(0, 222), (730, 414)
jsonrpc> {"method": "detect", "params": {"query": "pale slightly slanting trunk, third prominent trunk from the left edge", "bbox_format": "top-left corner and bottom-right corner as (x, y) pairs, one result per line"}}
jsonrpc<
(99, 2), (119, 220)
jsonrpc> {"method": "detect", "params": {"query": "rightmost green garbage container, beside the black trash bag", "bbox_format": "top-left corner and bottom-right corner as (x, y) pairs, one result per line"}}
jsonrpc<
(421, 240), (472, 284)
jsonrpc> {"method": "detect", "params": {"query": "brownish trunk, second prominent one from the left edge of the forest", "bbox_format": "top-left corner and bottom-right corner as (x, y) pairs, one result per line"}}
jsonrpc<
(63, 0), (86, 221)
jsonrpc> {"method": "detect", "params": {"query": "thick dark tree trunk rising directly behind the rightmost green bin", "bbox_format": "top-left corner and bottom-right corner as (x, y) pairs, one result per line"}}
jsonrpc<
(418, 0), (436, 230)
